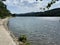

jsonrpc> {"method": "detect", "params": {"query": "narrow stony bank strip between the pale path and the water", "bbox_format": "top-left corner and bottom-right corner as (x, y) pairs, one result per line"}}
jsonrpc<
(2, 17), (19, 45)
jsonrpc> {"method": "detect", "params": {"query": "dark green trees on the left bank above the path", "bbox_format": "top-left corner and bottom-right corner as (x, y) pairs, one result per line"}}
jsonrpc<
(0, 1), (11, 19)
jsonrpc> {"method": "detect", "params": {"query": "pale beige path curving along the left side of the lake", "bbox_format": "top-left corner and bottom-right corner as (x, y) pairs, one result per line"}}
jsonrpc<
(0, 18), (16, 45)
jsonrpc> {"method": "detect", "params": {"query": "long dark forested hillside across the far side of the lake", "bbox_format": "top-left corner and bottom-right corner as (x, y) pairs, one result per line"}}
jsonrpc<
(13, 8), (60, 17)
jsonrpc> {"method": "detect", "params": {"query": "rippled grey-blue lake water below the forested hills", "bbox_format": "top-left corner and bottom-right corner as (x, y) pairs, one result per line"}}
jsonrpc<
(9, 17), (60, 45)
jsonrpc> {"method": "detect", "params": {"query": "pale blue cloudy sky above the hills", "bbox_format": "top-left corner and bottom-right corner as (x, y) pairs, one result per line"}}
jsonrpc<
(4, 0), (60, 14)
